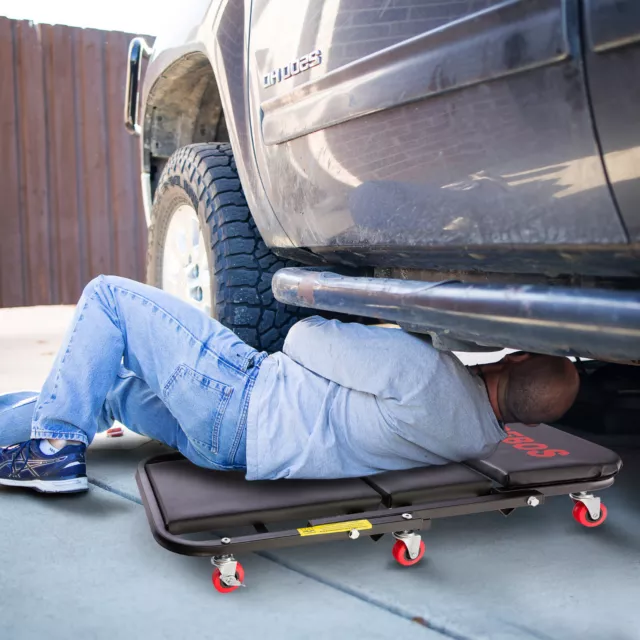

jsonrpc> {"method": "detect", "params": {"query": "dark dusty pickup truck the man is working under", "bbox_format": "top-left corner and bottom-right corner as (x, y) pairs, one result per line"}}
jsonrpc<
(125, 0), (640, 376)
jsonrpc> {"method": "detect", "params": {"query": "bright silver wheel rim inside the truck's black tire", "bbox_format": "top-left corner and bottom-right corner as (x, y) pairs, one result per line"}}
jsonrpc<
(162, 204), (211, 315)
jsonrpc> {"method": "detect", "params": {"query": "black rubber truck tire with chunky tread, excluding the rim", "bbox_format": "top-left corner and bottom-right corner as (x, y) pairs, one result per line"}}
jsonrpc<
(148, 143), (306, 351)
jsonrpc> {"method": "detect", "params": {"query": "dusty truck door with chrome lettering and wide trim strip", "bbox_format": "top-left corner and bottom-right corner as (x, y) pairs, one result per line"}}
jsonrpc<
(248, 0), (628, 266)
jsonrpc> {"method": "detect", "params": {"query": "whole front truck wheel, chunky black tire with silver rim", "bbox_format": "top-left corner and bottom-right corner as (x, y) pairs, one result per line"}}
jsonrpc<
(147, 144), (300, 351)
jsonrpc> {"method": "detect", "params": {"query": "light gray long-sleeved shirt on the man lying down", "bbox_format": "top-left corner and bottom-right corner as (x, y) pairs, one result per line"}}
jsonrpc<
(247, 317), (506, 480)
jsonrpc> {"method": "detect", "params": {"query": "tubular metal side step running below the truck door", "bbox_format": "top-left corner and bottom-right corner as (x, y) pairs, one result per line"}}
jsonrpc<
(272, 268), (640, 362)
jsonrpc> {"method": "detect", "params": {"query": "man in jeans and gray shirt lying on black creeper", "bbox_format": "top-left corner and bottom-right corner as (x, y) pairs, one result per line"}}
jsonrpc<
(0, 276), (579, 492)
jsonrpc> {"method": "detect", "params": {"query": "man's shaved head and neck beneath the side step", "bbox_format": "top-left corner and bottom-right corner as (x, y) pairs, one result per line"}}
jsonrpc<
(480, 353), (580, 424)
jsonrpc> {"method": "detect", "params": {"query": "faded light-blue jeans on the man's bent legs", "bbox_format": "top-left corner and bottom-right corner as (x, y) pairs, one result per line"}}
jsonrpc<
(0, 276), (266, 470)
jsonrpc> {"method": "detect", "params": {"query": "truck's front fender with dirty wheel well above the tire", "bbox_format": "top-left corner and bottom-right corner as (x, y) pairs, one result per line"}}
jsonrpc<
(140, 0), (308, 254)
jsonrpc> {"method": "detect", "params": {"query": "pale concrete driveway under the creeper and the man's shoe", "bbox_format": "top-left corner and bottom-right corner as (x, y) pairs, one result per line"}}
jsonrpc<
(0, 307), (640, 640)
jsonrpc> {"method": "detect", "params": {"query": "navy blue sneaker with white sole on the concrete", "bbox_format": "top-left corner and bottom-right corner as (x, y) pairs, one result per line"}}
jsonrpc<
(0, 440), (89, 493)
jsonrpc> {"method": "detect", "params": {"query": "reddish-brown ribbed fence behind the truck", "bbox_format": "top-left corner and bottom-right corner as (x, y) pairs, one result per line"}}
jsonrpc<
(0, 18), (151, 307)
